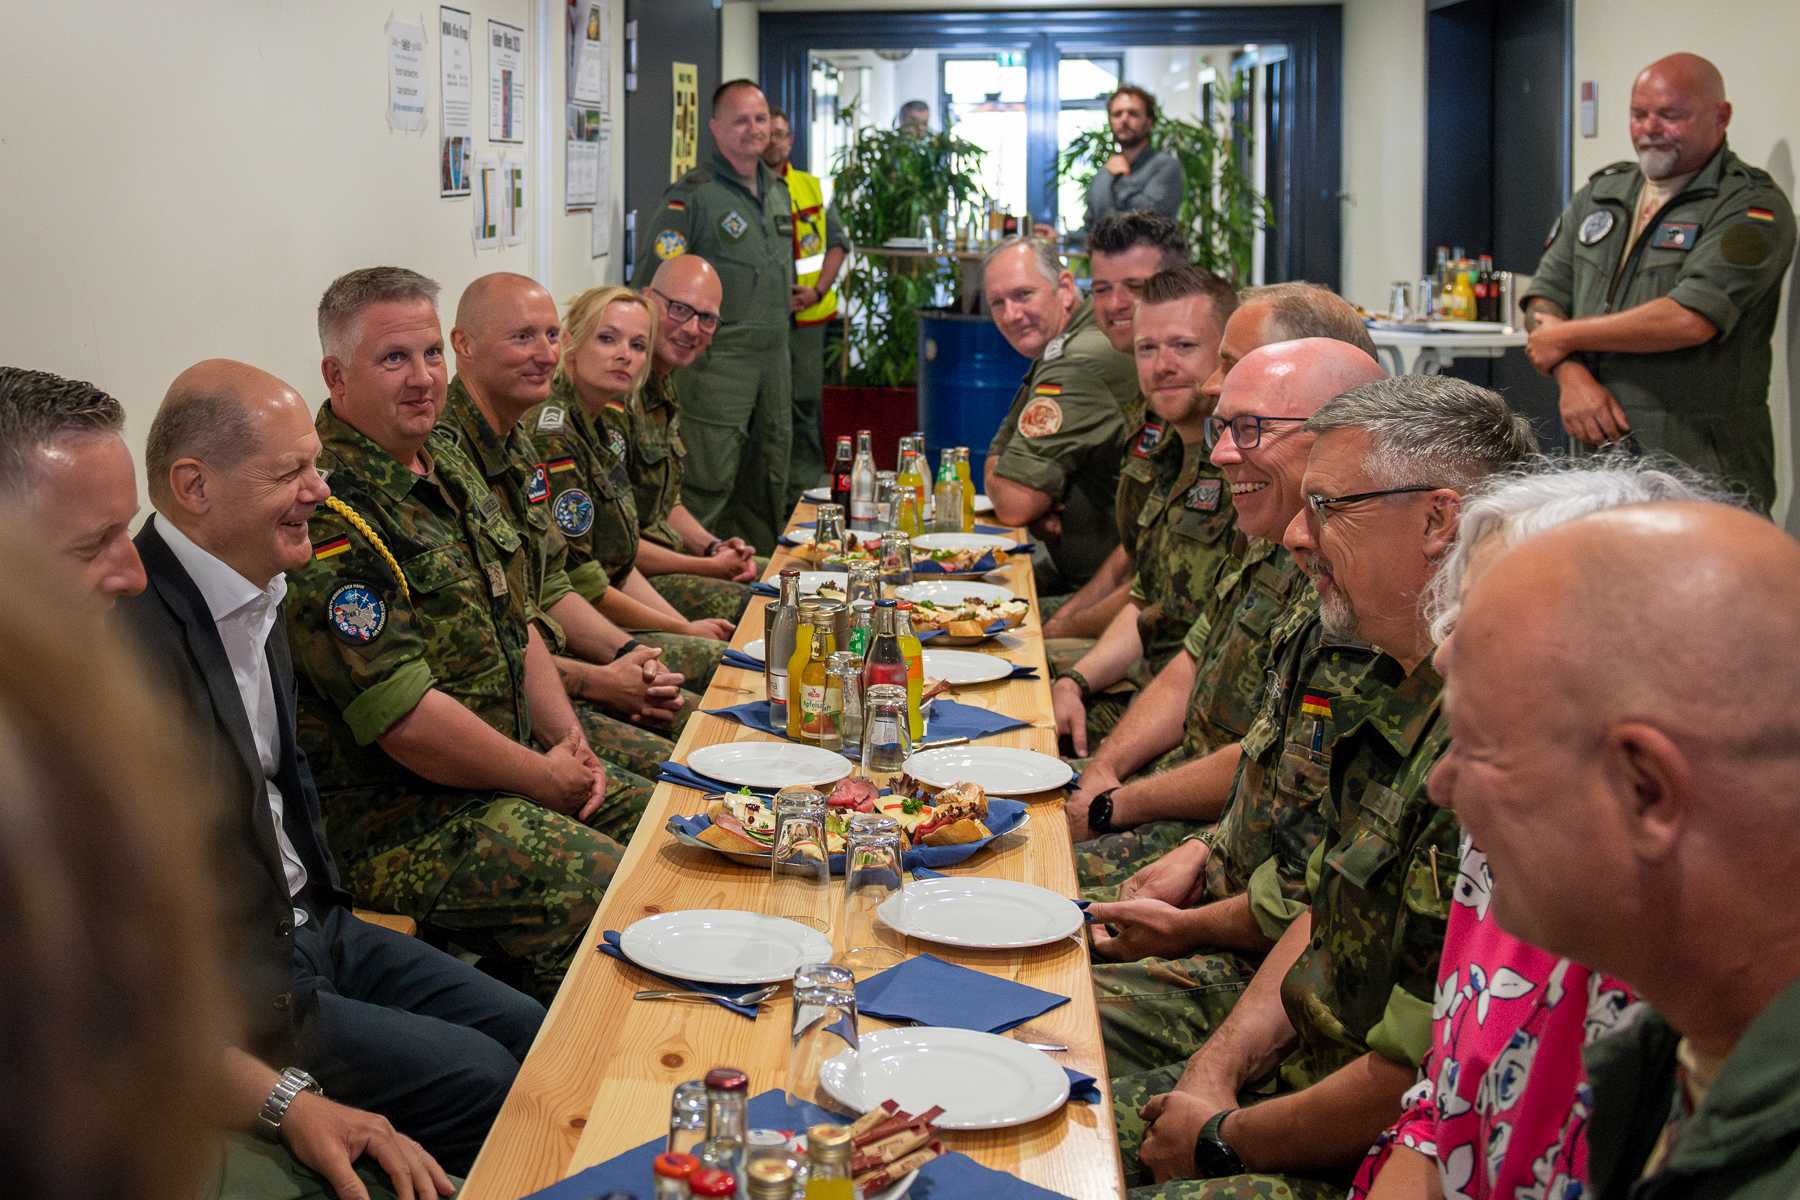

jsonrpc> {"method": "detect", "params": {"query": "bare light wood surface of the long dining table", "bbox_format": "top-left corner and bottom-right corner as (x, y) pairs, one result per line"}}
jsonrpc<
(463, 504), (1123, 1200)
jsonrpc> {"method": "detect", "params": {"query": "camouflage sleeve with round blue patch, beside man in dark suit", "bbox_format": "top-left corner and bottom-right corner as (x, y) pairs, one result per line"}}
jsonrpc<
(283, 509), (437, 745)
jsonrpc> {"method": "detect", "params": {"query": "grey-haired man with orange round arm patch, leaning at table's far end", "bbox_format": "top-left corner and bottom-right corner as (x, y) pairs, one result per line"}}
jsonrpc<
(981, 237), (1141, 597)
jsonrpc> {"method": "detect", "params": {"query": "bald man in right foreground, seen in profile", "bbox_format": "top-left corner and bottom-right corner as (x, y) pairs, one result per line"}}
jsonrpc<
(1431, 504), (1800, 1200)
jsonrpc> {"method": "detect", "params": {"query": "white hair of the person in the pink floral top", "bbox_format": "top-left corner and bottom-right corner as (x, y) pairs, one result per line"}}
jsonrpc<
(1424, 453), (1746, 642)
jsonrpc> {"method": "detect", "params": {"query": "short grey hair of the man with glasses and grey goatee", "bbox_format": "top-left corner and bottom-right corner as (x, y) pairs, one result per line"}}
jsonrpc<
(1307, 374), (1537, 491)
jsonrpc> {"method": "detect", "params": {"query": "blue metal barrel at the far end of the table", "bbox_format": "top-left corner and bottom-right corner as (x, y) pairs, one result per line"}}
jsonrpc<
(918, 309), (1031, 489)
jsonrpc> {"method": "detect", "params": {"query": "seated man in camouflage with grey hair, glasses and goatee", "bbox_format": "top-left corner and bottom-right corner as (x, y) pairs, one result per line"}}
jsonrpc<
(1114, 376), (1535, 1200)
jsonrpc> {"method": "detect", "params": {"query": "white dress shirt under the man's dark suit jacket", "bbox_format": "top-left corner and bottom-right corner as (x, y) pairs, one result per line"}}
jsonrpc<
(157, 520), (306, 925)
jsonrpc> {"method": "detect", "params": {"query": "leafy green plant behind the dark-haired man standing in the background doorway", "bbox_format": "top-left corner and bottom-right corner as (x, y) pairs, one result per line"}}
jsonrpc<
(1057, 80), (1274, 286)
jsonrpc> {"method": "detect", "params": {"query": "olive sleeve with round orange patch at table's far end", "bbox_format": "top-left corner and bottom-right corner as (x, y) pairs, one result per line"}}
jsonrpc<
(994, 362), (1125, 498)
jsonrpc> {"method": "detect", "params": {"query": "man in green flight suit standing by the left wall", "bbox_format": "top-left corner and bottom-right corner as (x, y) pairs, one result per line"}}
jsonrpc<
(632, 79), (794, 550)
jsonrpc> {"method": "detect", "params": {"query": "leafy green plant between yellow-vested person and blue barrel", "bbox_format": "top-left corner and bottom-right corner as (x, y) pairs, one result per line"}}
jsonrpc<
(828, 119), (985, 387)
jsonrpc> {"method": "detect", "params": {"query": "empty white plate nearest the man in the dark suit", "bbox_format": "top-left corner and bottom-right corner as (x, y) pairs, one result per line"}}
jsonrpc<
(619, 909), (832, 984)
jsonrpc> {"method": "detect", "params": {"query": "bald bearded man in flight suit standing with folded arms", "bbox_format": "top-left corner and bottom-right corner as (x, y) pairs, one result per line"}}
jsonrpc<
(1523, 54), (1795, 511)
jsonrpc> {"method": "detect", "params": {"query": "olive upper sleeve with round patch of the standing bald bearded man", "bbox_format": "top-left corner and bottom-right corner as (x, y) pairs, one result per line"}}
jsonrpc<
(1669, 185), (1795, 338)
